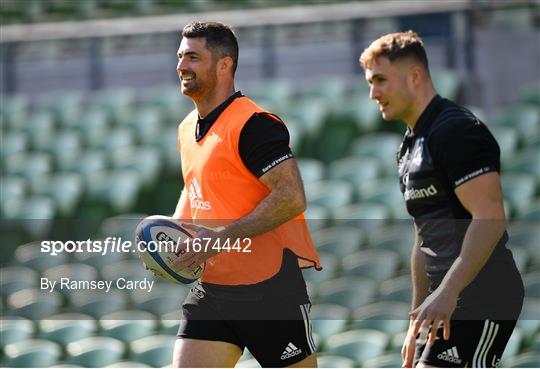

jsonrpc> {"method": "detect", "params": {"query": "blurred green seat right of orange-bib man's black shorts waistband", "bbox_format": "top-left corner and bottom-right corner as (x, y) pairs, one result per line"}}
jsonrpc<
(315, 278), (376, 310)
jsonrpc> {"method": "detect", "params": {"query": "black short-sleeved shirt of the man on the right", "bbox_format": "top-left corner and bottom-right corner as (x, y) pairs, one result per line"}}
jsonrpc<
(397, 95), (517, 300)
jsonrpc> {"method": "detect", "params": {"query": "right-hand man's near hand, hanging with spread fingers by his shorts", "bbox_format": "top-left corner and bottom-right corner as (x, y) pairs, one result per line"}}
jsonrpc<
(409, 287), (458, 346)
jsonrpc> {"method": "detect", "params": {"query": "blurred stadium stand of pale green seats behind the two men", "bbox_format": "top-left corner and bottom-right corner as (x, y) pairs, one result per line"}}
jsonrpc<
(0, 0), (540, 367)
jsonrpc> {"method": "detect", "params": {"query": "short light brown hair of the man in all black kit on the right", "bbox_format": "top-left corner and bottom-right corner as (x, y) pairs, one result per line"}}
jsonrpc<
(360, 31), (429, 74)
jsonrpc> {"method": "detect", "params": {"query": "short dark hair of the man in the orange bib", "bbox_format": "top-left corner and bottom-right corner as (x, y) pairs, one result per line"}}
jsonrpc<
(182, 22), (238, 75)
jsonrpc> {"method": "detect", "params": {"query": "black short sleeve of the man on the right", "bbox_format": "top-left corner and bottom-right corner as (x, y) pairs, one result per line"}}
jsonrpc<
(429, 119), (500, 188)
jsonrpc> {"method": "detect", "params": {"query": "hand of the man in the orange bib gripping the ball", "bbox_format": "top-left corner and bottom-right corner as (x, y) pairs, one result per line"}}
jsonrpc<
(172, 222), (223, 271)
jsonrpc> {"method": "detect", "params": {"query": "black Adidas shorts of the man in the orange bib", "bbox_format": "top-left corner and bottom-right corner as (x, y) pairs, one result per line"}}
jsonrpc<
(178, 284), (315, 367)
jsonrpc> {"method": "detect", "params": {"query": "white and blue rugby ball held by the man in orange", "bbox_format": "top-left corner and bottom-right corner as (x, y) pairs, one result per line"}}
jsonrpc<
(136, 215), (204, 284)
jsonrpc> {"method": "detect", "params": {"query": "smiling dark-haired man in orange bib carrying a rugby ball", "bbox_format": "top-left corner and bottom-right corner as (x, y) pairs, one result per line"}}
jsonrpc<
(173, 22), (320, 368)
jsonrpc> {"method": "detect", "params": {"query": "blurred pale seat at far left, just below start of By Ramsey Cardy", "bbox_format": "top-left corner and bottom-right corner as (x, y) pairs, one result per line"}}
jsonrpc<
(7, 288), (62, 320)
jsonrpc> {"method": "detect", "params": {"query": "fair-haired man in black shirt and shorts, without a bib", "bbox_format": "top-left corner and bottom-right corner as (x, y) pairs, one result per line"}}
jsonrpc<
(360, 31), (523, 367)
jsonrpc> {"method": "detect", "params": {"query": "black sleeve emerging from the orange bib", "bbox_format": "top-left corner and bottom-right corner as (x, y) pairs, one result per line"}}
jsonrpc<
(238, 113), (293, 178)
